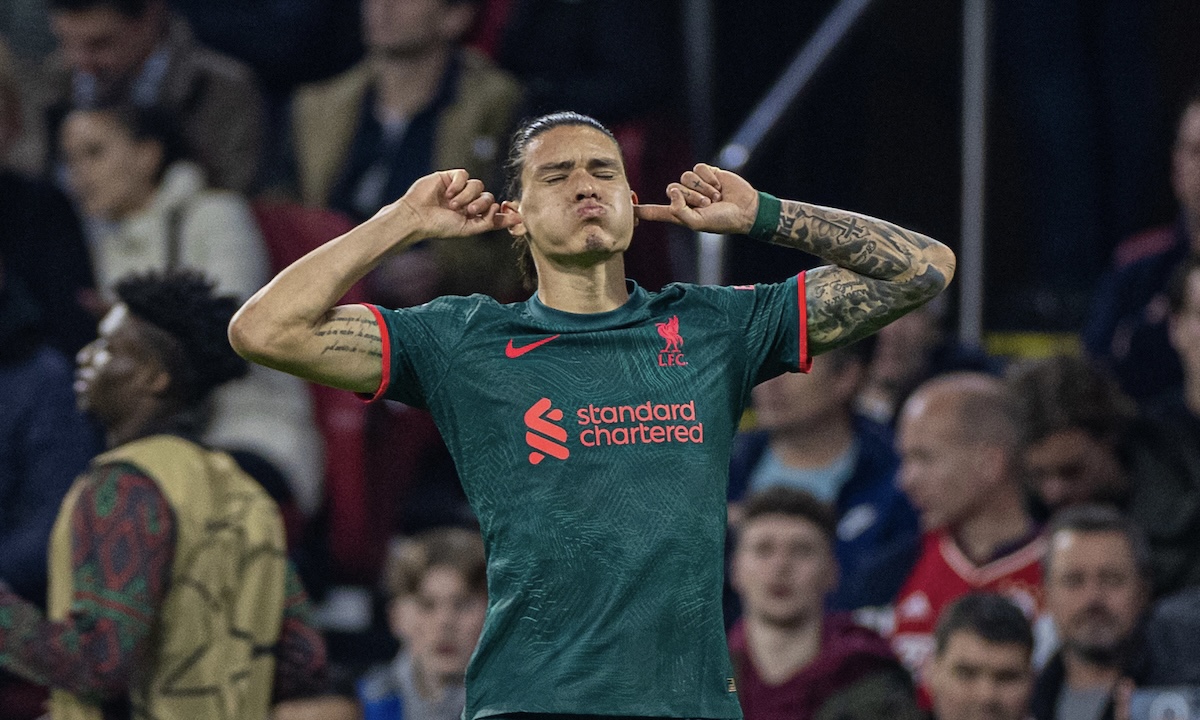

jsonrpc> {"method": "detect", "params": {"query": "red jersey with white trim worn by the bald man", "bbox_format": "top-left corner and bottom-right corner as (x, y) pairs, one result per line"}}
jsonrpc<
(892, 530), (1046, 708)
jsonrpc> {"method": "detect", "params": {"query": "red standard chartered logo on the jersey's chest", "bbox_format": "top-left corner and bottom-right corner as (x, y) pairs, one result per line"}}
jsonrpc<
(524, 397), (704, 464)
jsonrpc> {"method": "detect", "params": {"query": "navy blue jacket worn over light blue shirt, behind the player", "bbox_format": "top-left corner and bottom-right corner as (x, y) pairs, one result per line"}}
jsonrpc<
(728, 418), (920, 610)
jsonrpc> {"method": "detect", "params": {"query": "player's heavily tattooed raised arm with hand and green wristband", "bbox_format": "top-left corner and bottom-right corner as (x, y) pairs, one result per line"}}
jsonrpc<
(637, 163), (955, 355)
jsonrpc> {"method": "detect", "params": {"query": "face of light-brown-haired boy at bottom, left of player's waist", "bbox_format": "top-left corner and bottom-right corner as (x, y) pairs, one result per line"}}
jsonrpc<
(392, 566), (487, 683)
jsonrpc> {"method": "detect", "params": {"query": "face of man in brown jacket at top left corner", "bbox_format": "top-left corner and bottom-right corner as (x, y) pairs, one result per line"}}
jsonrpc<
(50, 7), (158, 94)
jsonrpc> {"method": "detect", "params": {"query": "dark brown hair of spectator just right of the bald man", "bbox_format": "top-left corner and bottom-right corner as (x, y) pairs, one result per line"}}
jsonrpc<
(1007, 355), (1136, 444)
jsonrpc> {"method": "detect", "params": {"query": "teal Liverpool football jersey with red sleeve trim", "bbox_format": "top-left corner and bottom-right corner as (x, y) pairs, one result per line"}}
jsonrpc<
(371, 275), (809, 720)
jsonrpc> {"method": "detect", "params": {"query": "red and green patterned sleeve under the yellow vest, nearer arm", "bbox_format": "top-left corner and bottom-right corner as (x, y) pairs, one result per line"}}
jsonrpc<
(0, 464), (175, 701)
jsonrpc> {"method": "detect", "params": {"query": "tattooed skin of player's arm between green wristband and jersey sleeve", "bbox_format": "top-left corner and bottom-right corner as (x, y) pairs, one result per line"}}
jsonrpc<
(772, 200), (954, 355)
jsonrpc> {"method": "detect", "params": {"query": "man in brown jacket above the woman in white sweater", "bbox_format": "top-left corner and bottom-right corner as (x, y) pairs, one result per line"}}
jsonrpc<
(37, 0), (265, 192)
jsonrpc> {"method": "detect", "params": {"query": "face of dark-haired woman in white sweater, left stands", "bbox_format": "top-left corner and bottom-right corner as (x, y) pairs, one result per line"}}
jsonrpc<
(62, 110), (162, 220)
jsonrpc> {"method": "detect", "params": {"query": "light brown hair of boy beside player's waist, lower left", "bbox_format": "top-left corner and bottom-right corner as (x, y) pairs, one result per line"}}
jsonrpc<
(383, 527), (487, 600)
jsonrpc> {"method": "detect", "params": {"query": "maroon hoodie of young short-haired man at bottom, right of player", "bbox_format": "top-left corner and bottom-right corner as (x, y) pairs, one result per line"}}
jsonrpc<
(730, 613), (899, 720)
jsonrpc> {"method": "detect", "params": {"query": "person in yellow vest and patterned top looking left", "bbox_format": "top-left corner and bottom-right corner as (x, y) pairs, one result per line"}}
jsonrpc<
(0, 272), (325, 720)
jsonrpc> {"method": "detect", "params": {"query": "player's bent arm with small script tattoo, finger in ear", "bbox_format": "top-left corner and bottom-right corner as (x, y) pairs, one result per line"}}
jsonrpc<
(229, 170), (506, 392)
